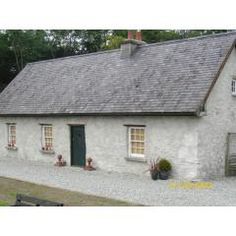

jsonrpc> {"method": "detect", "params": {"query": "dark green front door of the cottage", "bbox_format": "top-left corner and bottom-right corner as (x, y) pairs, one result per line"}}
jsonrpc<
(71, 125), (86, 166)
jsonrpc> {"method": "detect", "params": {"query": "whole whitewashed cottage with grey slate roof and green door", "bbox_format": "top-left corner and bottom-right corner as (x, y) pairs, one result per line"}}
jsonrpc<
(0, 32), (236, 179)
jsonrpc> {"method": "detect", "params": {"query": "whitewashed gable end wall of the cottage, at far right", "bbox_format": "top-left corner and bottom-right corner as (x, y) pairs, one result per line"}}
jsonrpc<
(198, 49), (236, 178)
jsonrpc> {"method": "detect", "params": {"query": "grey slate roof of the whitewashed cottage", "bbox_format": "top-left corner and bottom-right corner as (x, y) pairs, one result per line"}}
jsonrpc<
(0, 32), (236, 115)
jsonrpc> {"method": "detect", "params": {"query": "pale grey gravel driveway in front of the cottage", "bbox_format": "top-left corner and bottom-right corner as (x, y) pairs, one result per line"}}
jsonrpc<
(0, 158), (236, 206)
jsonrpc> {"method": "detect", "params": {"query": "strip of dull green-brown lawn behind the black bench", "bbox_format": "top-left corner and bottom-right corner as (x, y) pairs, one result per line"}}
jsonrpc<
(0, 177), (135, 206)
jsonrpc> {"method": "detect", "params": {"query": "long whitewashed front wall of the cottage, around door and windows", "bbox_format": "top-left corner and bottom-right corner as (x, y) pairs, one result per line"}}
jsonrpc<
(0, 116), (199, 178)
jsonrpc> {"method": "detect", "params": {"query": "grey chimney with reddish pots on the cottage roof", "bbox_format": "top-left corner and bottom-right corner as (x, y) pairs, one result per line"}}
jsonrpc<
(121, 30), (145, 58)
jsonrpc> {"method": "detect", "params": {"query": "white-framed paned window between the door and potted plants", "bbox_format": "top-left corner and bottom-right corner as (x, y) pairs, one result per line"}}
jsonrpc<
(129, 127), (145, 157)
